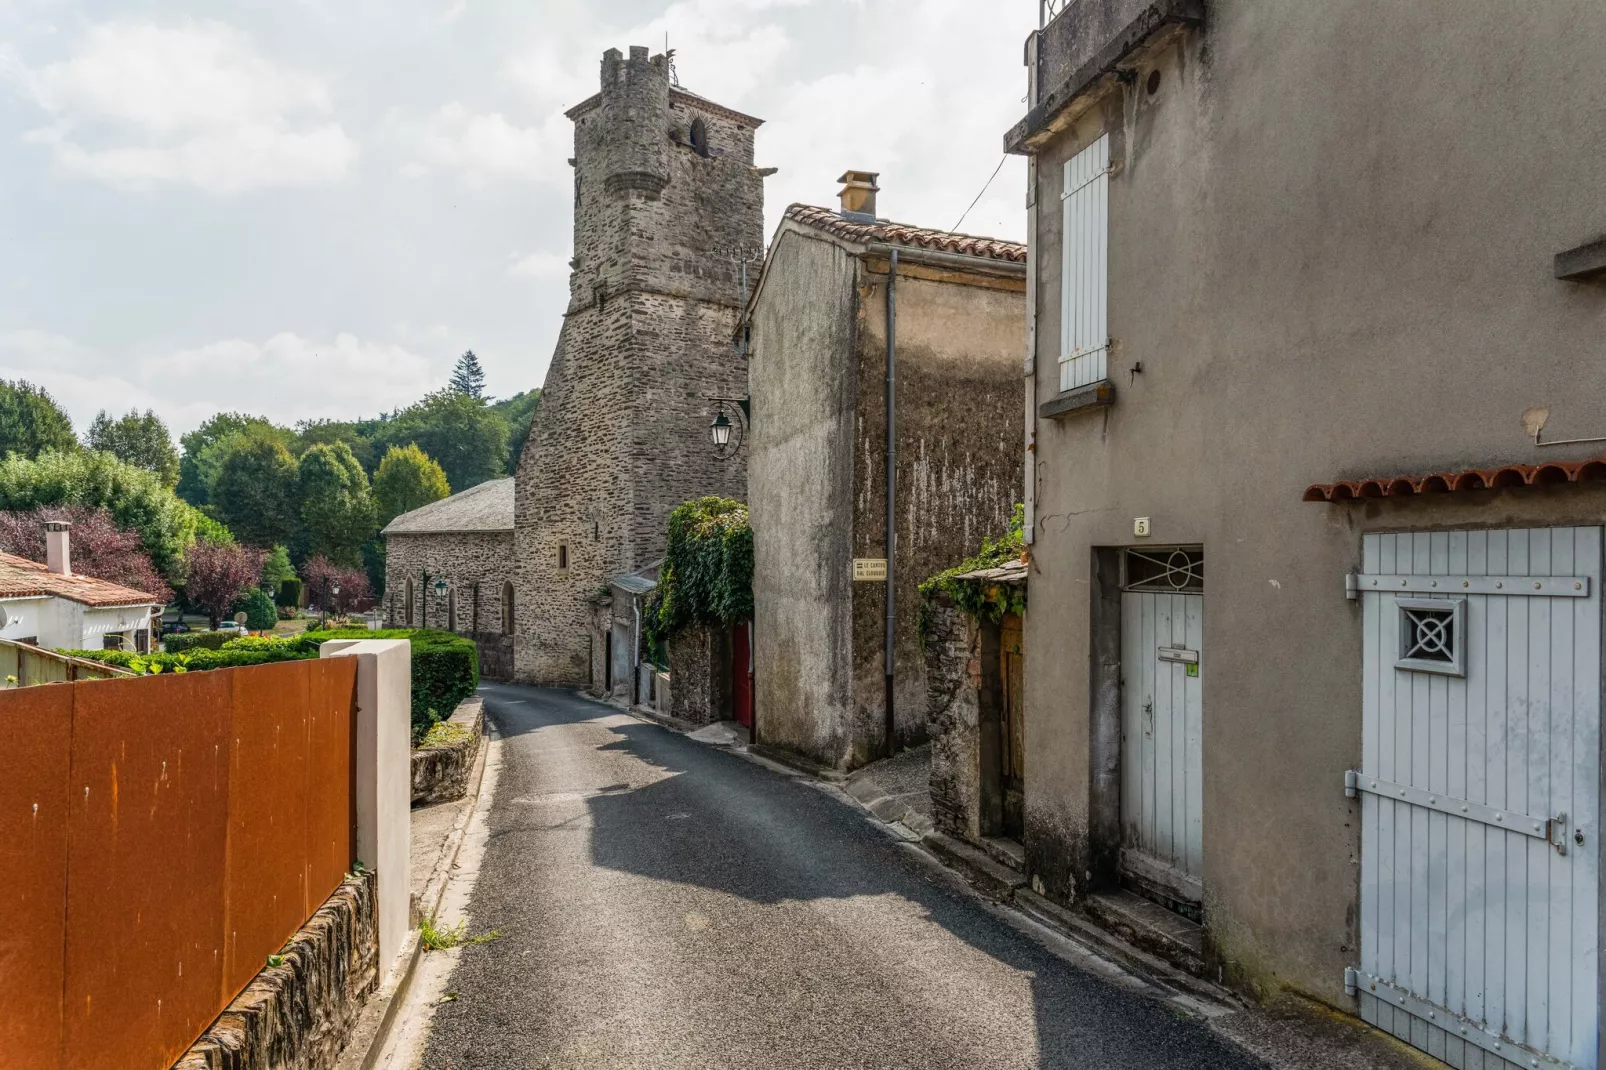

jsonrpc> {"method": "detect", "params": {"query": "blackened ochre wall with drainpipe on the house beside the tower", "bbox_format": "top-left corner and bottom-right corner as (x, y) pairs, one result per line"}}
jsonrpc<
(854, 262), (1026, 766)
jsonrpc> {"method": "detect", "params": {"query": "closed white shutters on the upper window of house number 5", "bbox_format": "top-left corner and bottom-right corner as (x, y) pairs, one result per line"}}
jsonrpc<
(1060, 133), (1110, 390)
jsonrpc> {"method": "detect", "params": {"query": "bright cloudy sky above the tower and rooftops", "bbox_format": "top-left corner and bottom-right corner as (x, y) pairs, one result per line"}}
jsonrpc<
(0, 0), (1037, 434)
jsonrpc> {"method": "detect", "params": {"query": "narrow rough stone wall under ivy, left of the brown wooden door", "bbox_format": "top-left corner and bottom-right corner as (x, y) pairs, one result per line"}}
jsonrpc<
(925, 604), (981, 843)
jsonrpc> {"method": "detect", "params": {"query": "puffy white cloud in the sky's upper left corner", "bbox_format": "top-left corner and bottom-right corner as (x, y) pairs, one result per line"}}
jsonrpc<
(27, 21), (357, 194)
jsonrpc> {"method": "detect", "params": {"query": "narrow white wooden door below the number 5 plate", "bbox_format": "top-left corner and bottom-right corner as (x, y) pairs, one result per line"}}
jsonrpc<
(1121, 591), (1205, 901)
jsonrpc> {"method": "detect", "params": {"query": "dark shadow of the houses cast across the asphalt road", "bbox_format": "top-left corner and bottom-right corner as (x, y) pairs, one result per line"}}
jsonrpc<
(468, 686), (1262, 1070)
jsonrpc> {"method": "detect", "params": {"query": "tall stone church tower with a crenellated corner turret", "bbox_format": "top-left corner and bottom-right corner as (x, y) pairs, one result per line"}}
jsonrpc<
(514, 48), (766, 686)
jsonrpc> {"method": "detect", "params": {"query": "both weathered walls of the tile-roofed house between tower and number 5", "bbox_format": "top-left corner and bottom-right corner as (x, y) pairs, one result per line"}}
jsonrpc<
(748, 206), (1026, 770)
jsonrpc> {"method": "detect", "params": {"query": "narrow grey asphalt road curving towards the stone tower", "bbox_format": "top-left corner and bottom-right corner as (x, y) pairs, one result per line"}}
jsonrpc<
(424, 686), (1262, 1070)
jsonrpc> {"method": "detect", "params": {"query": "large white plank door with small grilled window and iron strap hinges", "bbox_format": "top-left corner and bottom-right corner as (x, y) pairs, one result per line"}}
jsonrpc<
(1346, 527), (1601, 1070)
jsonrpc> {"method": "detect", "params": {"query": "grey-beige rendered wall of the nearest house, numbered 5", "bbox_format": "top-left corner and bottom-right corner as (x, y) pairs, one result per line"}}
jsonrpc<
(1026, 0), (1606, 1004)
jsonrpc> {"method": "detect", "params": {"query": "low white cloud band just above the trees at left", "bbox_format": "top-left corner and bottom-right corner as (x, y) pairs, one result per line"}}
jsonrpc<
(0, 329), (450, 435)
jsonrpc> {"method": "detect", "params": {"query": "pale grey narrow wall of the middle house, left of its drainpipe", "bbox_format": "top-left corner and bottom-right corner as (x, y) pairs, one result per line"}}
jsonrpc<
(748, 233), (856, 755)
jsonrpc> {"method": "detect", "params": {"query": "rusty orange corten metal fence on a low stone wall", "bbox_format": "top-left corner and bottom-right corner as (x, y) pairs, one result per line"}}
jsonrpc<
(0, 657), (357, 1070)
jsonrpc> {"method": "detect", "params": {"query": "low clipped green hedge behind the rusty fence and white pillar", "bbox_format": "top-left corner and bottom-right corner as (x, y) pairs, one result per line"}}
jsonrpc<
(63, 628), (480, 739)
